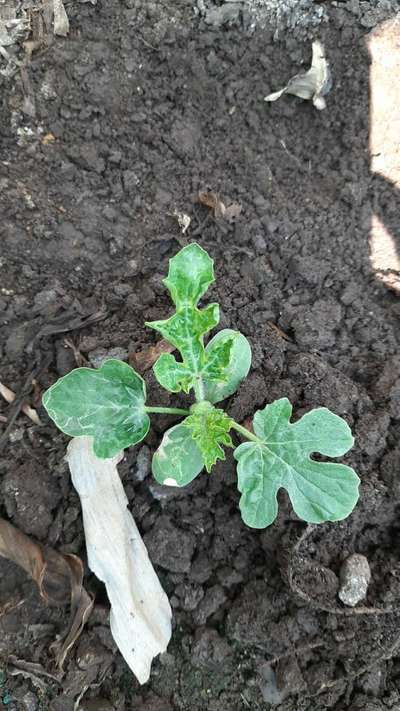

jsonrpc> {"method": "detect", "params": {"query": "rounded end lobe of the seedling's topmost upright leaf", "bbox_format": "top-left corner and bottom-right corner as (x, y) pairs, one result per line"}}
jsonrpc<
(164, 242), (214, 309)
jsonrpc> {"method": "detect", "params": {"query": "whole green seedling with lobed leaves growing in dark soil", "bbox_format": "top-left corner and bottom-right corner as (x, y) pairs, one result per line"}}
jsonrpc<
(43, 243), (359, 528)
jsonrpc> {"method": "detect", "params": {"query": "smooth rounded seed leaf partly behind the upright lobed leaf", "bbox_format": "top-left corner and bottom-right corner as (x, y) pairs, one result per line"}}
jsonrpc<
(204, 328), (251, 403)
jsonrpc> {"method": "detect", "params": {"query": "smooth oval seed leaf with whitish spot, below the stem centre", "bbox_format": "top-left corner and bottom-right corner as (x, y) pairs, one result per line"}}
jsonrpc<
(152, 423), (204, 486)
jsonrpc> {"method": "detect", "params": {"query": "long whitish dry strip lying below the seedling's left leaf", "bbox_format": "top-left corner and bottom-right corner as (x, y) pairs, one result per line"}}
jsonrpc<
(66, 437), (171, 684)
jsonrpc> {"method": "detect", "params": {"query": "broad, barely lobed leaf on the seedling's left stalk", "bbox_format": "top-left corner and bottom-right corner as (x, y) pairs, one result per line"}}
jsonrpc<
(43, 359), (150, 459)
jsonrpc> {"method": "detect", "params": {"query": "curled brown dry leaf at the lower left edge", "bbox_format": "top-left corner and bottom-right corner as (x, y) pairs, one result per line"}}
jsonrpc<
(0, 518), (93, 669)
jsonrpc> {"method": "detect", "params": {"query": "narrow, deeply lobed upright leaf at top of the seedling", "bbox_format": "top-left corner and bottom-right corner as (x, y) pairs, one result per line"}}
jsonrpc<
(146, 243), (241, 402)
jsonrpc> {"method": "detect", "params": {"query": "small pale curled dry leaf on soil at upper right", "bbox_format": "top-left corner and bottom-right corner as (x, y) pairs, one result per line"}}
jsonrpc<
(264, 40), (331, 110)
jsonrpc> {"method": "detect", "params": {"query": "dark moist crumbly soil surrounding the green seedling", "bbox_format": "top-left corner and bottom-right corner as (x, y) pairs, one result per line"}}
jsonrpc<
(0, 0), (400, 711)
